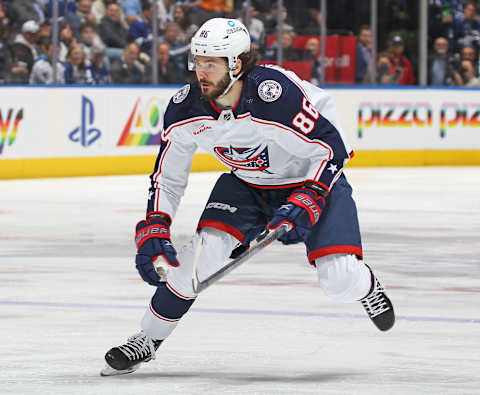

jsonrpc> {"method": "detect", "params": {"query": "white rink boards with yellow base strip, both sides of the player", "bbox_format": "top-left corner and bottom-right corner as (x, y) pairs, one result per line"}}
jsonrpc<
(0, 86), (480, 179)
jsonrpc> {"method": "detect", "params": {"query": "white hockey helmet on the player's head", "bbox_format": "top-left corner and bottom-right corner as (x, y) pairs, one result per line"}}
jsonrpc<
(189, 18), (250, 73)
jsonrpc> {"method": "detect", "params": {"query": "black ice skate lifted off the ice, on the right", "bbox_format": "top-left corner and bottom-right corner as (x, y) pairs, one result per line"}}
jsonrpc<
(360, 270), (395, 331)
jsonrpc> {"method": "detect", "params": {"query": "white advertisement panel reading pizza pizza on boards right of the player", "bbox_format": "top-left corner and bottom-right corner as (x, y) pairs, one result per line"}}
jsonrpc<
(332, 89), (480, 151)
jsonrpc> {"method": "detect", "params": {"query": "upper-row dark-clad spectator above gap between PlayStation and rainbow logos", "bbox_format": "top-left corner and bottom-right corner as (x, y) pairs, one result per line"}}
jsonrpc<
(98, 3), (128, 57)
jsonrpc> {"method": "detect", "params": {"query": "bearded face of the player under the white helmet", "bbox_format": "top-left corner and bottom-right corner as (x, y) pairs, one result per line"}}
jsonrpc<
(195, 56), (230, 100)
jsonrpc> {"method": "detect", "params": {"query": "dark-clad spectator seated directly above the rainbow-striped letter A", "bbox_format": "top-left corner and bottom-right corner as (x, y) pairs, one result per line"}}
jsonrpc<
(110, 43), (145, 84)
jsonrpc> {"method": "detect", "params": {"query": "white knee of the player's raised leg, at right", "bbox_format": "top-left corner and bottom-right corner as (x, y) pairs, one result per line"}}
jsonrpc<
(315, 254), (372, 302)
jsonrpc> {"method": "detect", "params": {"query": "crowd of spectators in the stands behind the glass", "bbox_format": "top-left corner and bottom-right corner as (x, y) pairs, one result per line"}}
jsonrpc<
(0, 0), (480, 87)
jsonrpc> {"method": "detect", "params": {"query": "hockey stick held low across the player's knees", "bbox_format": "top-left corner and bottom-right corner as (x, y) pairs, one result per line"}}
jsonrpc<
(192, 223), (292, 294)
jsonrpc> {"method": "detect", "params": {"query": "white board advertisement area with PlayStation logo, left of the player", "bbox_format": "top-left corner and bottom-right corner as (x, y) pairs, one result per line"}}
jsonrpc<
(0, 87), (177, 159)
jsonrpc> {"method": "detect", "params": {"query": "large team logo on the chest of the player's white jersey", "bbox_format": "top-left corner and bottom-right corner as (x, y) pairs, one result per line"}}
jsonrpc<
(214, 144), (270, 172)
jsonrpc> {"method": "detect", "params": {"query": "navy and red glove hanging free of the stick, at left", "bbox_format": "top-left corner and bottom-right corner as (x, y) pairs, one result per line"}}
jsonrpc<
(135, 211), (179, 286)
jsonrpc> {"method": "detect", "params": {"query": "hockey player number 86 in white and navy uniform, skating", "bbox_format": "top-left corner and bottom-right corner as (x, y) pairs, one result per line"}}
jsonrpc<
(102, 18), (395, 375)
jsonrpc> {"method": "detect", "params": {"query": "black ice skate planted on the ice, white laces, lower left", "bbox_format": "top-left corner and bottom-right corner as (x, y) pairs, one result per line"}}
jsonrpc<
(100, 331), (163, 376)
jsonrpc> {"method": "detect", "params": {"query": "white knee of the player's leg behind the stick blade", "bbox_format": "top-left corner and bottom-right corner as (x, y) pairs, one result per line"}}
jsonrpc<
(167, 227), (238, 298)
